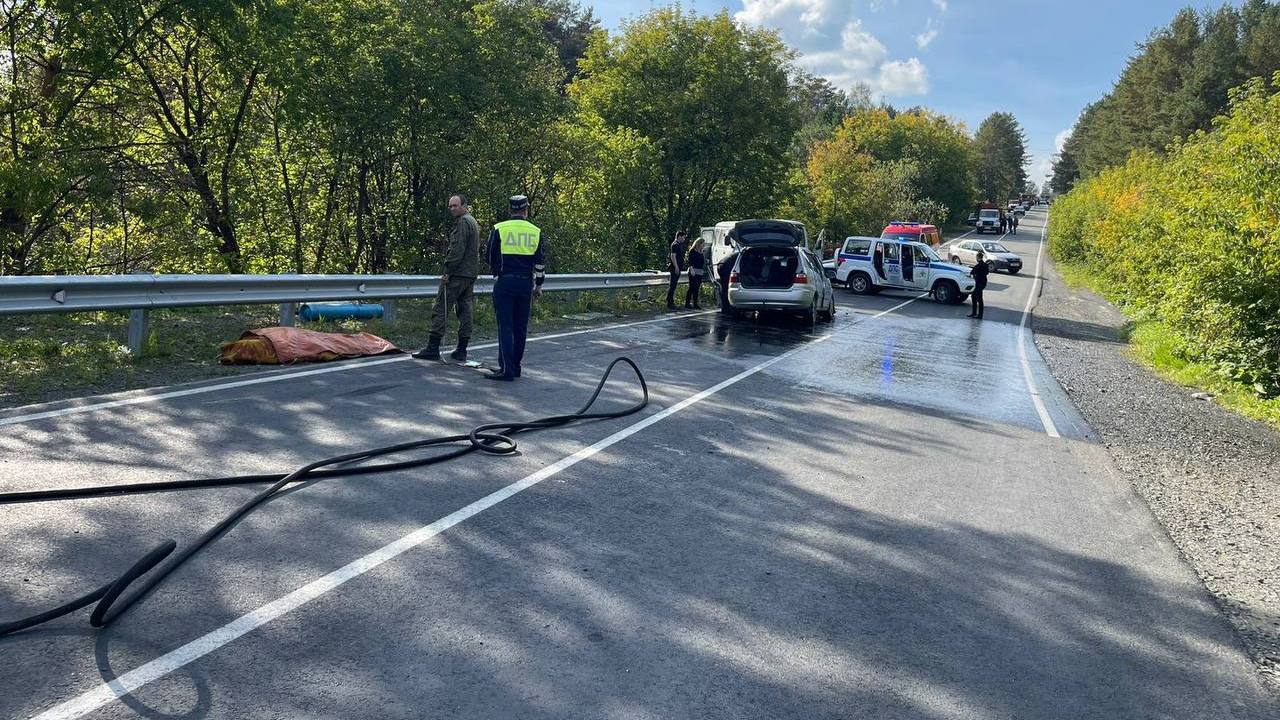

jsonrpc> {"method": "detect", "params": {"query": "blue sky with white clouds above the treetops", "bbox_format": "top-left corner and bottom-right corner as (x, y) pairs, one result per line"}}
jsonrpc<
(593, 0), (1213, 183)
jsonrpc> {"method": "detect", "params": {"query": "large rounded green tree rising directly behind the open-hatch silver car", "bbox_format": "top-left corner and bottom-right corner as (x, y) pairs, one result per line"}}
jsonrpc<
(570, 8), (797, 261)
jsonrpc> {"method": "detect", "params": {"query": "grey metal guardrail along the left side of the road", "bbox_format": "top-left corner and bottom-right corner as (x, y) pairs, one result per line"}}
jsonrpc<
(0, 273), (668, 355)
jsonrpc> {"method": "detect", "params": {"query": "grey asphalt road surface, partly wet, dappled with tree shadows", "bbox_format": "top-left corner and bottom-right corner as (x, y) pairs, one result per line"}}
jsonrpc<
(0, 213), (1280, 720)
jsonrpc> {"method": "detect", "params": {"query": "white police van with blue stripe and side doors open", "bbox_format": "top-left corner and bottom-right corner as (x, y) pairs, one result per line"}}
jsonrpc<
(836, 237), (974, 304)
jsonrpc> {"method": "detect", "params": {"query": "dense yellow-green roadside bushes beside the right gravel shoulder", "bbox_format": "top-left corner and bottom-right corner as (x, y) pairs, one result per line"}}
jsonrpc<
(1048, 73), (1280, 397)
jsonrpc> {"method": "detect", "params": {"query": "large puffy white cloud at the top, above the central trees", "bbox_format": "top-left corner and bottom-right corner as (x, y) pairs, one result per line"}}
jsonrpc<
(735, 0), (946, 96)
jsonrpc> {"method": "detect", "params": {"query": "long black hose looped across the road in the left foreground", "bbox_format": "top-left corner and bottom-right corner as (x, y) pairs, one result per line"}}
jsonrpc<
(0, 357), (649, 637)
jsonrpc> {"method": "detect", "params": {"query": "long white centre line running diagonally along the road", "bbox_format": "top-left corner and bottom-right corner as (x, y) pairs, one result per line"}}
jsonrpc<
(33, 293), (928, 720)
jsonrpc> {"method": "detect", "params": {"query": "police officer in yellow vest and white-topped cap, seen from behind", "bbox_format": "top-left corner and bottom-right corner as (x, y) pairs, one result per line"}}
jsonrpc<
(485, 195), (547, 382)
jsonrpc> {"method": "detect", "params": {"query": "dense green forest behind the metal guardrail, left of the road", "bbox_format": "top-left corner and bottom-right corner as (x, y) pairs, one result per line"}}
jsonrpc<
(0, 0), (1028, 275)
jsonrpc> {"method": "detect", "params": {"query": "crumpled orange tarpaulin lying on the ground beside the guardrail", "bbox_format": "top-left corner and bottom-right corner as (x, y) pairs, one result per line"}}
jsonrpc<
(218, 328), (399, 365)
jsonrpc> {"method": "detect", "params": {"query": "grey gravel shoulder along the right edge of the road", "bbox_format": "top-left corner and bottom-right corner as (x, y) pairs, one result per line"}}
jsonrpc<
(1034, 249), (1280, 694)
